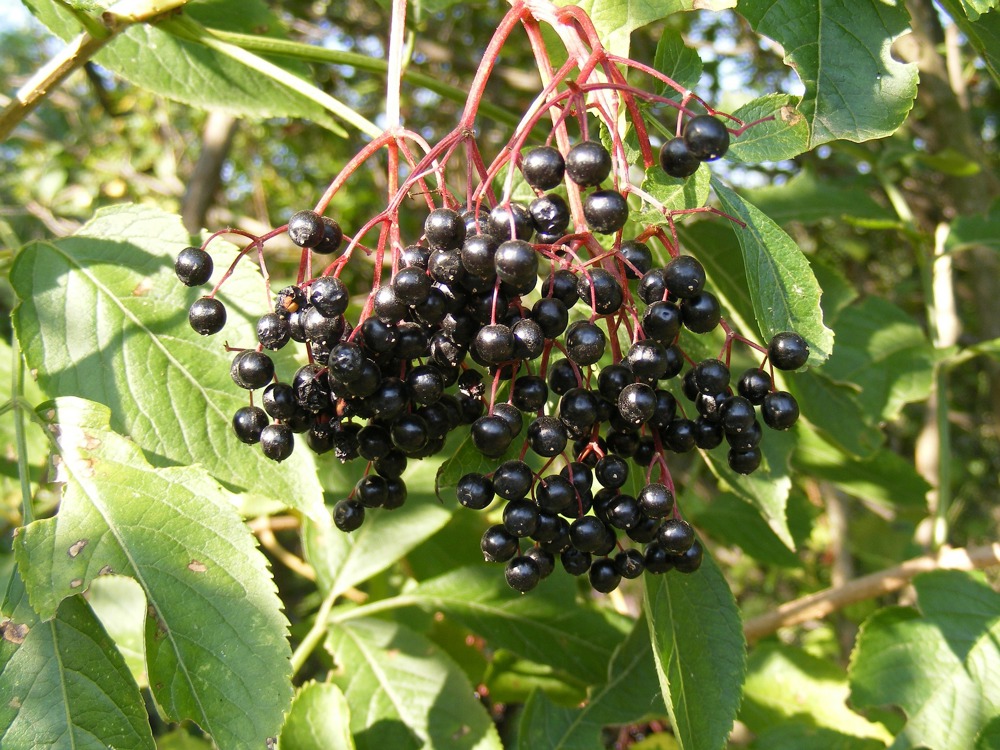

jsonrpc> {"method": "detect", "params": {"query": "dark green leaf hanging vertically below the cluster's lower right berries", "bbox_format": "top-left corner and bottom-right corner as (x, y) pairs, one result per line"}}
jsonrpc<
(644, 552), (746, 750)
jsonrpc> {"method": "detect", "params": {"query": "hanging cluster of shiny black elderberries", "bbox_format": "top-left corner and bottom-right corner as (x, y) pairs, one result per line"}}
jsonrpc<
(175, 115), (809, 592)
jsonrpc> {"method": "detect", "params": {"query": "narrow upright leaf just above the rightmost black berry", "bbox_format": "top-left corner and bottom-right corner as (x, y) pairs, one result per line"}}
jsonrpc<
(712, 180), (833, 365)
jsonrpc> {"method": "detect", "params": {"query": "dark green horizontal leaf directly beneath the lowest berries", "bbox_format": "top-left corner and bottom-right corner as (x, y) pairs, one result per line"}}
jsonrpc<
(376, 565), (624, 684)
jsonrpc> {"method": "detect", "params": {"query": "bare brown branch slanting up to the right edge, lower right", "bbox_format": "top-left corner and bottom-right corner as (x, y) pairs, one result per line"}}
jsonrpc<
(743, 543), (1000, 642)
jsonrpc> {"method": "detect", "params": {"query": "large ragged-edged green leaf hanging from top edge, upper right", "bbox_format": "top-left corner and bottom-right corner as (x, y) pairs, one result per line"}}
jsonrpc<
(736, 0), (917, 148)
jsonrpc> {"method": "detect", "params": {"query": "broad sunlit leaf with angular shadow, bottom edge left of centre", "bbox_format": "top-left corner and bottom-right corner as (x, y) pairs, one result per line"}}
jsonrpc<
(327, 618), (502, 750)
